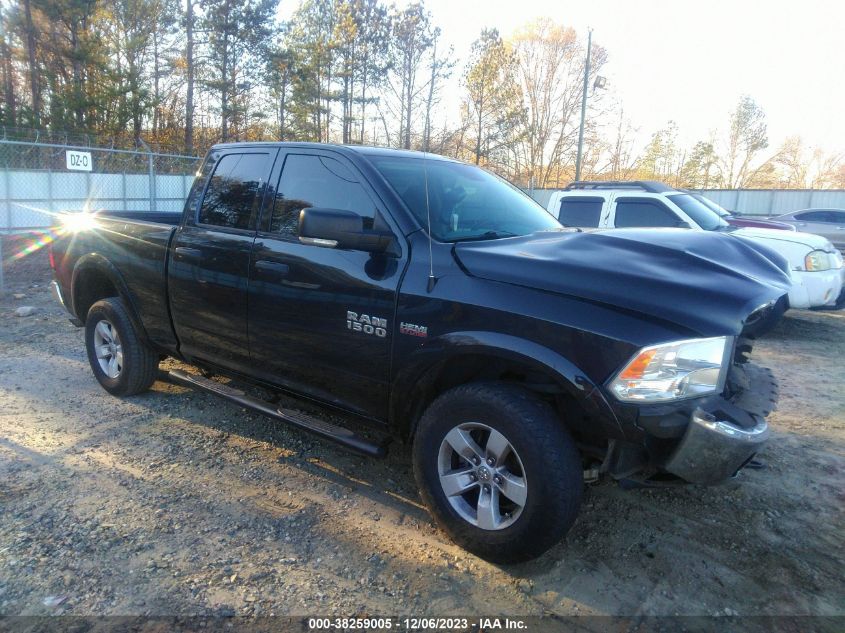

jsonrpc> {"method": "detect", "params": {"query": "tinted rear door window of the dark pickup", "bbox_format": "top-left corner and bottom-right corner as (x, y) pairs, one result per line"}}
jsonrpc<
(198, 154), (267, 230)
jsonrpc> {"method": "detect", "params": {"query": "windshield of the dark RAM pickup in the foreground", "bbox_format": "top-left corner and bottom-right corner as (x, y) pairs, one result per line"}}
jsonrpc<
(369, 156), (561, 242)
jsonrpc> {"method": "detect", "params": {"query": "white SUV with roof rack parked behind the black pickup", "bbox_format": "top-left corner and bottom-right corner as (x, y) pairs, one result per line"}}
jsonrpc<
(546, 180), (845, 308)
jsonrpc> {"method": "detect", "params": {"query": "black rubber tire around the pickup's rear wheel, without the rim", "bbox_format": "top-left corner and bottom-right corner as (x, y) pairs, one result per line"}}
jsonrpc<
(85, 297), (159, 396)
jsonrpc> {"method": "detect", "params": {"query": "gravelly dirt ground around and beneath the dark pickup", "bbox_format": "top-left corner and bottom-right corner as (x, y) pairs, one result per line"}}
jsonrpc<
(0, 237), (845, 616)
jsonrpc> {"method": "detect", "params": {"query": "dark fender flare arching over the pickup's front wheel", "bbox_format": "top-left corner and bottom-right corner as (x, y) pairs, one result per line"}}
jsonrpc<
(389, 331), (624, 439)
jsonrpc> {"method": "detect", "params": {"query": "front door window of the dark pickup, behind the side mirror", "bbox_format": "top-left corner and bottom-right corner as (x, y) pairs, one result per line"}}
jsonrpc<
(270, 154), (376, 237)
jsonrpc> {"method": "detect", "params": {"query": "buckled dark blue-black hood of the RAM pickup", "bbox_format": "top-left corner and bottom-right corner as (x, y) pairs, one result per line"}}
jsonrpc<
(454, 229), (791, 336)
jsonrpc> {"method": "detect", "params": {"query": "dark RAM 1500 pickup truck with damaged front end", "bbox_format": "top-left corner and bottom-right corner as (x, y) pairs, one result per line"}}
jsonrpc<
(52, 143), (789, 562)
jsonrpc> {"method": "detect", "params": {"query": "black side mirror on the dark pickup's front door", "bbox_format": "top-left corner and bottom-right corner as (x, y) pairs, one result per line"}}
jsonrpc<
(299, 207), (393, 253)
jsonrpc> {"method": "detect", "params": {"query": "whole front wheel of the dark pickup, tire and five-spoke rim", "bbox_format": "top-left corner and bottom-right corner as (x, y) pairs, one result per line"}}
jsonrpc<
(413, 383), (584, 563)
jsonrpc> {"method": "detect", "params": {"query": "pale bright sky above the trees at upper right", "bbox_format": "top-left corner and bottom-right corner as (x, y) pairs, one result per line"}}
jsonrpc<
(282, 0), (845, 151)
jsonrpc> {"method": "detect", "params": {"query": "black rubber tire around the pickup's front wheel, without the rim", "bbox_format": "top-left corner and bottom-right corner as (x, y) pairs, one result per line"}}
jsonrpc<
(413, 383), (584, 563)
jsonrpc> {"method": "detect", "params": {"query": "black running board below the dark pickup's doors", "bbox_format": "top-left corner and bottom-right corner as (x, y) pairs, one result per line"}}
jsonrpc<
(167, 369), (387, 457)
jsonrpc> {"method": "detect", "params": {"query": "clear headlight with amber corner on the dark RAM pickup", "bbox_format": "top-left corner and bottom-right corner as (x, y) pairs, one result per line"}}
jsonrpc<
(610, 336), (733, 402)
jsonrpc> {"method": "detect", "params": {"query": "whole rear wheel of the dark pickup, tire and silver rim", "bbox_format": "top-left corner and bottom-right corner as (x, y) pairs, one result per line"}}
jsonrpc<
(85, 297), (159, 396)
